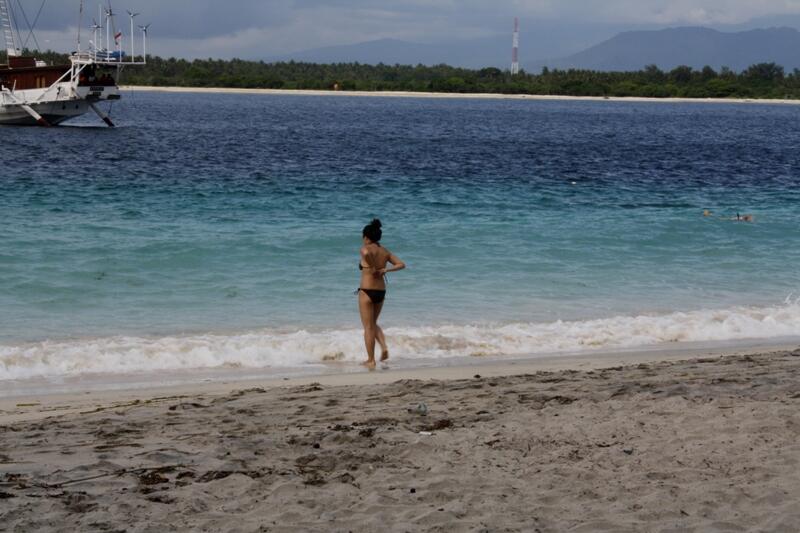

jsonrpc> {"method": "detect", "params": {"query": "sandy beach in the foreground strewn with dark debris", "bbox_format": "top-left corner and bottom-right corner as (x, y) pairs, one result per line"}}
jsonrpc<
(0, 350), (800, 532)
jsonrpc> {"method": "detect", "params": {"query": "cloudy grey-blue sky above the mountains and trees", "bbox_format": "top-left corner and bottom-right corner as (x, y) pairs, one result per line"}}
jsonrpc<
(13, 0), (800, 58)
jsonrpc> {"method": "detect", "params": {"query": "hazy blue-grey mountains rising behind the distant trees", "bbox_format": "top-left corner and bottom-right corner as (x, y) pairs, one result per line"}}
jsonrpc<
(268, 27), (800, 72)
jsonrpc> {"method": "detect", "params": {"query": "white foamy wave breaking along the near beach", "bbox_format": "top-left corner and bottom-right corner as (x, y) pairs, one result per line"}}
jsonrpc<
(0, 301), (800, 380)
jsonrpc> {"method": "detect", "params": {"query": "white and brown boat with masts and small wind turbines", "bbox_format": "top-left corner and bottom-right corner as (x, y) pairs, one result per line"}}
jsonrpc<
(0, 0), (149, 127)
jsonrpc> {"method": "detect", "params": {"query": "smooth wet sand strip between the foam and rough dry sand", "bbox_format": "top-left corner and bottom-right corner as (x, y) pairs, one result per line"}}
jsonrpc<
(0, 342), (798, 426)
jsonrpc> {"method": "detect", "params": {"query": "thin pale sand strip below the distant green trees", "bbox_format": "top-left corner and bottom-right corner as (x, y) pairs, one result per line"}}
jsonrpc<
(120, 85), (800, 105)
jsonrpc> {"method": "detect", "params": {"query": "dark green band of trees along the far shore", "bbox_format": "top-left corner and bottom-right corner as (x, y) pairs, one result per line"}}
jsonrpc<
(6, 52), (800, 99)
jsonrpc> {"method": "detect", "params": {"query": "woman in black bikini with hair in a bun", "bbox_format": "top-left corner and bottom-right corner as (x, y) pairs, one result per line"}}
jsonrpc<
(358, 218), (406, 369)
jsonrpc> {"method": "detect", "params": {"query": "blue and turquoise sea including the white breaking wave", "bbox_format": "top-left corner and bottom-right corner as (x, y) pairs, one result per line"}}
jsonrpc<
(0, 92), (800, 386)
